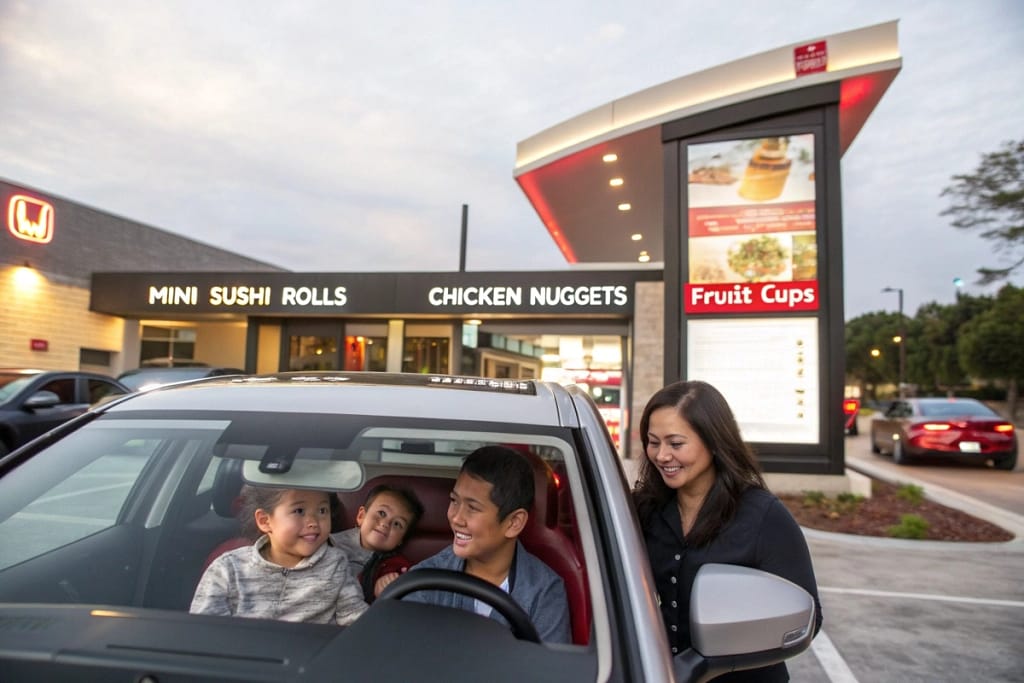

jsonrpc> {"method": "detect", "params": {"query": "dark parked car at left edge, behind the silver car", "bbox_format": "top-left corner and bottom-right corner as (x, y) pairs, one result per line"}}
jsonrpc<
(0, 368), (130, 456)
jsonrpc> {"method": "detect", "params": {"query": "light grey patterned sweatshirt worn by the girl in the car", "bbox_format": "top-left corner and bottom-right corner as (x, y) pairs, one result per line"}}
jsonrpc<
(188, 536), (369, 626)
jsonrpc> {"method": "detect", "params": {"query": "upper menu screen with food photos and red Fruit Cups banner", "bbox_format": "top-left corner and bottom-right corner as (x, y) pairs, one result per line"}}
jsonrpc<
(683, 133), (819, 313)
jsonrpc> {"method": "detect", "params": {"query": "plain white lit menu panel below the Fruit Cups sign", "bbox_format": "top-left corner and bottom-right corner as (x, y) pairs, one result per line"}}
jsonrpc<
(686, 317), (820, 443)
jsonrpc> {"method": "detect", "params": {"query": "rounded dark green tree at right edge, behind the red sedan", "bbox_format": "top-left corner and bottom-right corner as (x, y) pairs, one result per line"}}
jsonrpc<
(956, 285), (1024, 417)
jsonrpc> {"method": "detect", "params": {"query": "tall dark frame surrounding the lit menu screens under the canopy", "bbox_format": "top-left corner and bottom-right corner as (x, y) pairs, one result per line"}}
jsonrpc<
(662, 84), (848, 474)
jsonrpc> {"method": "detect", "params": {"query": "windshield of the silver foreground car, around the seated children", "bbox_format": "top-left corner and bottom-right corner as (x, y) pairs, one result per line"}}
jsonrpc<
(0, 405), (589, 611)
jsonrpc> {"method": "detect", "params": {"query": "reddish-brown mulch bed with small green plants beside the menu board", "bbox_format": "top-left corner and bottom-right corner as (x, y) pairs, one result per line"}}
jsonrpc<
(779, 479), (1014, 543)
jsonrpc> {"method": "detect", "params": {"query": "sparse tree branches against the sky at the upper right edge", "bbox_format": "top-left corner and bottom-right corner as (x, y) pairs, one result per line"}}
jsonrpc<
(941, 140), (1024, 285)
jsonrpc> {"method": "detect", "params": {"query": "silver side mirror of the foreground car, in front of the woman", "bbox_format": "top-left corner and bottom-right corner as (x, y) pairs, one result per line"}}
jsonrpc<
(675, 564), (815, 681)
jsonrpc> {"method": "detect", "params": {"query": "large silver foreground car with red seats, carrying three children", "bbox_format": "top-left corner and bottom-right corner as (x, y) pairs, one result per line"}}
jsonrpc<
(0, 373), (815, 683)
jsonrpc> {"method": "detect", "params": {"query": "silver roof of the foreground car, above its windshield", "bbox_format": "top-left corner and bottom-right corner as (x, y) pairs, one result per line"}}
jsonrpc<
(102, 372), (579, 427)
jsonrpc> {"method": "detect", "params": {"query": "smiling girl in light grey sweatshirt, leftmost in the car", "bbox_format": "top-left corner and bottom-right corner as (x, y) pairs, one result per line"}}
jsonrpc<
(189, 485), (368, 626)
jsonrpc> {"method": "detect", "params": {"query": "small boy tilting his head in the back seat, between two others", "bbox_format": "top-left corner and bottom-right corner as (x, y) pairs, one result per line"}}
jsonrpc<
(331, 484), (423, 603)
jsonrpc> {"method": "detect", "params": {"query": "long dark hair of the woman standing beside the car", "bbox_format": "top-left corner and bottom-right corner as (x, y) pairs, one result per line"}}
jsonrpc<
(633, 381), (765, 546)
